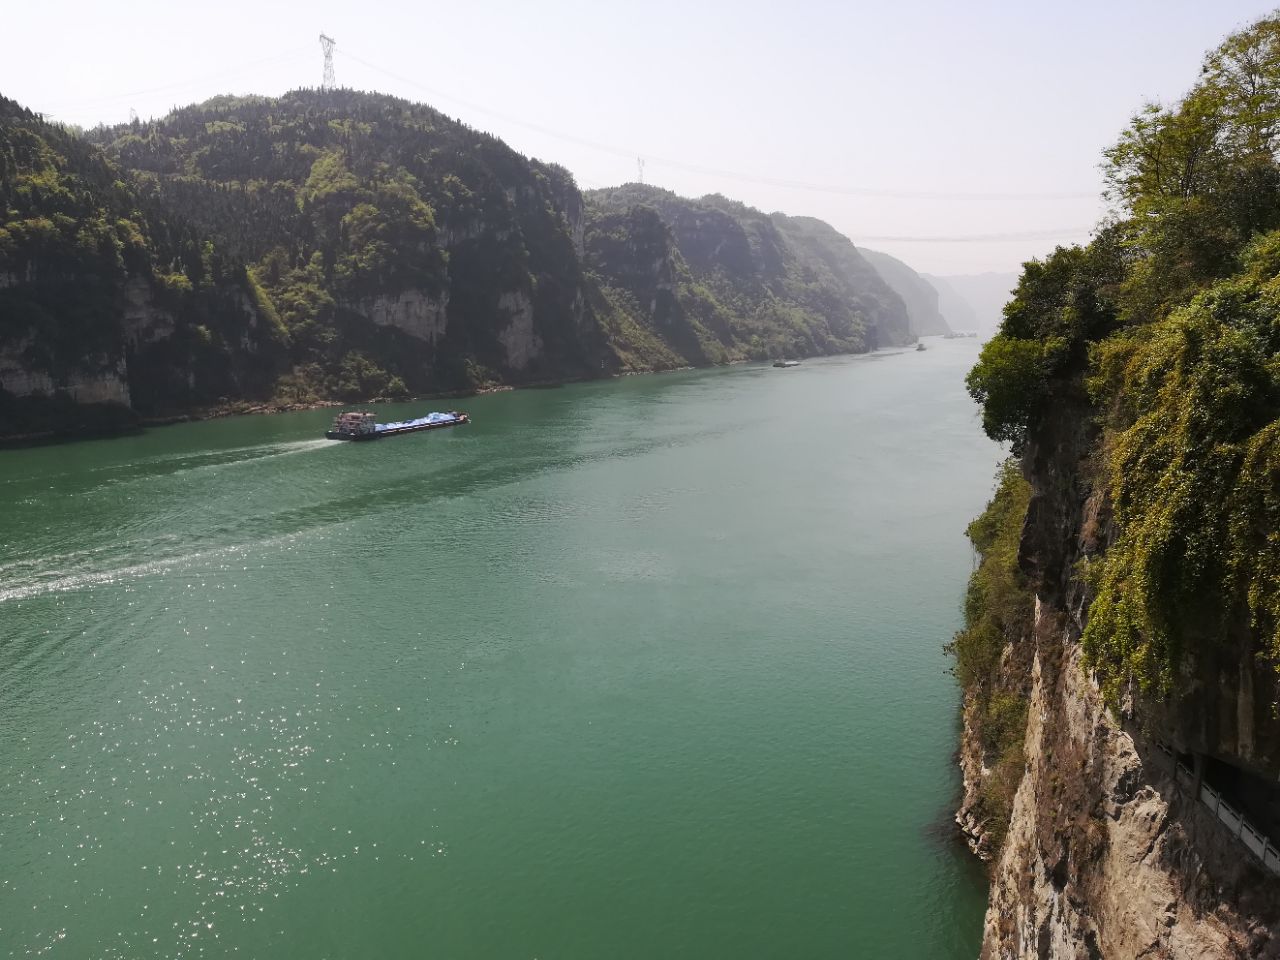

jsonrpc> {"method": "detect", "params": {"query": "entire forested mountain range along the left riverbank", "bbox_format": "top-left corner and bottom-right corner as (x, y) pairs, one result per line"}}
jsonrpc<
(0, 90), (911, 440)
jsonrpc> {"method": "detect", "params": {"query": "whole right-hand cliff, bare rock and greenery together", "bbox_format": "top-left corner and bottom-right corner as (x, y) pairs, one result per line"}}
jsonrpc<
(954, 17), (1280, 957)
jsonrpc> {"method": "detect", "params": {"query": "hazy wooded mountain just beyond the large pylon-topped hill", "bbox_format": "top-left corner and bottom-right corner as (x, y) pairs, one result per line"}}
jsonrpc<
(585, 183), (911, 366)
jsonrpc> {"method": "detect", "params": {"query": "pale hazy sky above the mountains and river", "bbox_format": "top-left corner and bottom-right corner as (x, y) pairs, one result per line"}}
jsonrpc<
(0, 0), (1271, 274)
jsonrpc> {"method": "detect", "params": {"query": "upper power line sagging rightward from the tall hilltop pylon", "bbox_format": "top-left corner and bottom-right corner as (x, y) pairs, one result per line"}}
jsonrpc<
(332, 51), (1098, 200)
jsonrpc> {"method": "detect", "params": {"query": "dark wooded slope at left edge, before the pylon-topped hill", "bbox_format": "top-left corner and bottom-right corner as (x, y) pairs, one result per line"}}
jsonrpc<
(0, 99), (284, 430)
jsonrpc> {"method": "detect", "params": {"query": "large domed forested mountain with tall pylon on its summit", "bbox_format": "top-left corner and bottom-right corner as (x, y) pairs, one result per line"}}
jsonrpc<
(92, 90), (616, 402)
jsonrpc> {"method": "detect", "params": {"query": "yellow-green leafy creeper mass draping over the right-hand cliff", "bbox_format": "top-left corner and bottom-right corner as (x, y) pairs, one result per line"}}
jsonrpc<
(1084, 259), (1280, 698)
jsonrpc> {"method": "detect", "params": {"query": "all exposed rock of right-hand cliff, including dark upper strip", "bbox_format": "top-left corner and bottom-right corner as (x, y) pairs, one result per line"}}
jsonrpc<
(957, 396), (1280, 960)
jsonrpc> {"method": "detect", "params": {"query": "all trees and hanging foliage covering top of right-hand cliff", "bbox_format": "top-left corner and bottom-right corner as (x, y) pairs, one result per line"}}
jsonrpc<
(969, 17), (1280, 699)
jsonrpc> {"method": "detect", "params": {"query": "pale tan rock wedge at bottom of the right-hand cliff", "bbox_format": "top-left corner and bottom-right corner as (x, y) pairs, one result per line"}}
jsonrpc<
(966, 603), (1280, 960)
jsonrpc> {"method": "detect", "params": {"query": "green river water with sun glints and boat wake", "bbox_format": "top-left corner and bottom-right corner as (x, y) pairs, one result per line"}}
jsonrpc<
(0, 340), (1000, 960)
